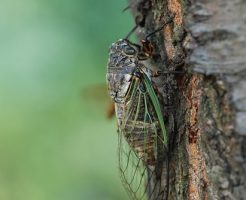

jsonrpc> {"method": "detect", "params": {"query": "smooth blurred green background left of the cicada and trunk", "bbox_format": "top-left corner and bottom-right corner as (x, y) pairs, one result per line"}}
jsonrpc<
(0, 0), (133, 200)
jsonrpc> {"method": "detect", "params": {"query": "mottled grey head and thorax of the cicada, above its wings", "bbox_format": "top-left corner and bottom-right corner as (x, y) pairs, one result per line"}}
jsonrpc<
(106, 39), (139, 103)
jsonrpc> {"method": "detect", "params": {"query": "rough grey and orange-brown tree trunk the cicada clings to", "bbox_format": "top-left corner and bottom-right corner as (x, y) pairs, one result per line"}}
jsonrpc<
(130, 0), (246, 200)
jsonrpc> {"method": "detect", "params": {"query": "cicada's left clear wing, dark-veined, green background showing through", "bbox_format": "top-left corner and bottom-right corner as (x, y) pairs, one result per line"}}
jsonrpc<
(117, 81), (148, 200)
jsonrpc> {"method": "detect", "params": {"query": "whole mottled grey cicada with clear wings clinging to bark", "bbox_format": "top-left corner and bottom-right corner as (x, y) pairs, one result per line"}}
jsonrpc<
(106, 39), (168, 200)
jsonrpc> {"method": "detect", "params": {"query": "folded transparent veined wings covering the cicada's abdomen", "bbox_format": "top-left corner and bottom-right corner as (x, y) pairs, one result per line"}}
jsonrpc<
(118, 75), (167, 200)
